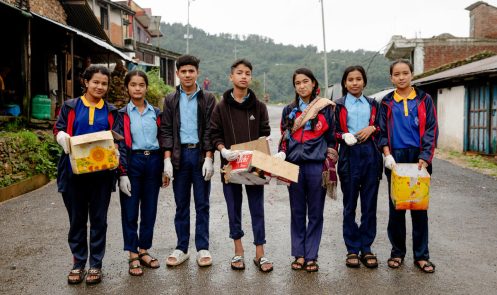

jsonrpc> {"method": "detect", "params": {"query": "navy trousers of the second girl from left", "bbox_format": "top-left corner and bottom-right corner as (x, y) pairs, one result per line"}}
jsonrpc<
(119, 153), (163, 253)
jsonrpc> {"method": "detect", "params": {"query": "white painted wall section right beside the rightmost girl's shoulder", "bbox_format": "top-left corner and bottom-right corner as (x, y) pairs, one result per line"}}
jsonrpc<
(437, 86), (466, 152)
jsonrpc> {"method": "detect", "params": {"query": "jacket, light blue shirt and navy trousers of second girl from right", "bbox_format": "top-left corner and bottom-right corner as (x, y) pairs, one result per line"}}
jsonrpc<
(335, 94), (382, 254)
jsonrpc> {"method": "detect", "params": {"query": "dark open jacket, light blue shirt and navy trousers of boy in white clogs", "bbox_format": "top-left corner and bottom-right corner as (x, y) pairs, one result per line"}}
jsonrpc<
(160, 85), (216, 253)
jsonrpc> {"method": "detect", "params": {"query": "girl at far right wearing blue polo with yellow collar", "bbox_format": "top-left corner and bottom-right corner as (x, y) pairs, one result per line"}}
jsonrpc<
(378, 60), (438, 273)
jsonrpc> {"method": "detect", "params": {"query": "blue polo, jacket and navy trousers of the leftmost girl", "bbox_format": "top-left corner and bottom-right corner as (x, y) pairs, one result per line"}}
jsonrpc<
(54, 97), (117, 269)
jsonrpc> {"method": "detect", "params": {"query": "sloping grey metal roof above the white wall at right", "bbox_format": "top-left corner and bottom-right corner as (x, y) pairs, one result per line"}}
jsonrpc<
(412, 56), (497, 85)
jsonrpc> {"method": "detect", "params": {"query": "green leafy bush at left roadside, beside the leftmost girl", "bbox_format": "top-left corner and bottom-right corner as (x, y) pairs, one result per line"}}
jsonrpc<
(0, 130), (62, 187)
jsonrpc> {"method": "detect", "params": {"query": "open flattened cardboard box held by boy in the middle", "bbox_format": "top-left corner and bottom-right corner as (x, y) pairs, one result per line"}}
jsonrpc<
(223, 150), (299, 185)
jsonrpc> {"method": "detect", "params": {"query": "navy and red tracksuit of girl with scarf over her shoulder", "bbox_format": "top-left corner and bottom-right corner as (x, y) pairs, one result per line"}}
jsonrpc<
(279, 101), (335, 262)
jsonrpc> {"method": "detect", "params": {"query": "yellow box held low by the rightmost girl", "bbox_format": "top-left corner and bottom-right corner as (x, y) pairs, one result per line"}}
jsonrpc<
(390, 164), (430, 210)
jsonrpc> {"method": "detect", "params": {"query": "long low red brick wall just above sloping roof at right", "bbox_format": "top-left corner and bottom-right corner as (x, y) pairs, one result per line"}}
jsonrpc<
(423, 42), (497, 72)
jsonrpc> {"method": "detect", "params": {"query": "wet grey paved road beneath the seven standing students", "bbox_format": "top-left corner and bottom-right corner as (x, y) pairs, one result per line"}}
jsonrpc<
(0, 107), (497, 295)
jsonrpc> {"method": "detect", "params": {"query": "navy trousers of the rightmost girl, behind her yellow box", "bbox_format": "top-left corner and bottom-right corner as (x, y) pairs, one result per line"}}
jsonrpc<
(385, 148), (432, 261)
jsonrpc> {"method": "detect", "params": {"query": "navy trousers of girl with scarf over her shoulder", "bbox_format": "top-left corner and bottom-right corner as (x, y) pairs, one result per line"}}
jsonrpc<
(288, 162), (326, 261)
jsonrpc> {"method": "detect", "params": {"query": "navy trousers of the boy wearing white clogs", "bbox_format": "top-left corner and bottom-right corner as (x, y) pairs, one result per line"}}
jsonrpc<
(173, 148), (211, 253)
